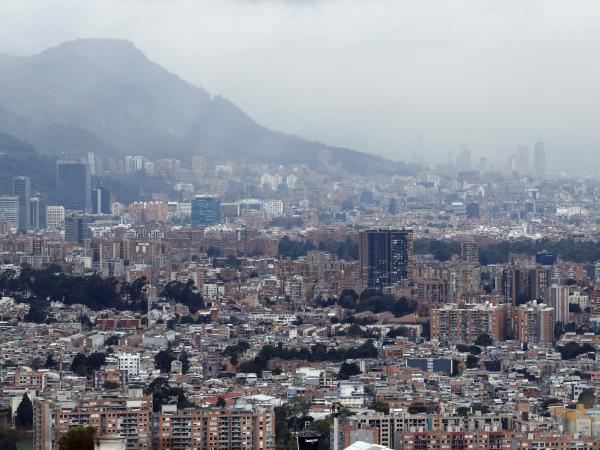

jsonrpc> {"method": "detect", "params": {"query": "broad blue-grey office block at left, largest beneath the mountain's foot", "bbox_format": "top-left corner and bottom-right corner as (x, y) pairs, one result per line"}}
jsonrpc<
(56, 159), (92, 212)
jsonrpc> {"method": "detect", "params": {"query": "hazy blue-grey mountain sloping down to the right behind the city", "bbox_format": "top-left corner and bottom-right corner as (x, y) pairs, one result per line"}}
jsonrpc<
(0, 39), (405, 173)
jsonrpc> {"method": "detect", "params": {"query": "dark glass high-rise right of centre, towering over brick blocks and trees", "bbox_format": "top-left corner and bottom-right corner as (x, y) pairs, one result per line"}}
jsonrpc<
(359, 230), (413, 290)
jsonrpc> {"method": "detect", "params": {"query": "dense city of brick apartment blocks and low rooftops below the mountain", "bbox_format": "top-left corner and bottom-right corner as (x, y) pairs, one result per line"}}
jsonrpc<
(0, 138), (600, 450)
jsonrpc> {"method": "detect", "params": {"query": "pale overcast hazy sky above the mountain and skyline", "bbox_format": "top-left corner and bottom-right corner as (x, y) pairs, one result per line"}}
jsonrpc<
(0, 0), (600, 172)
